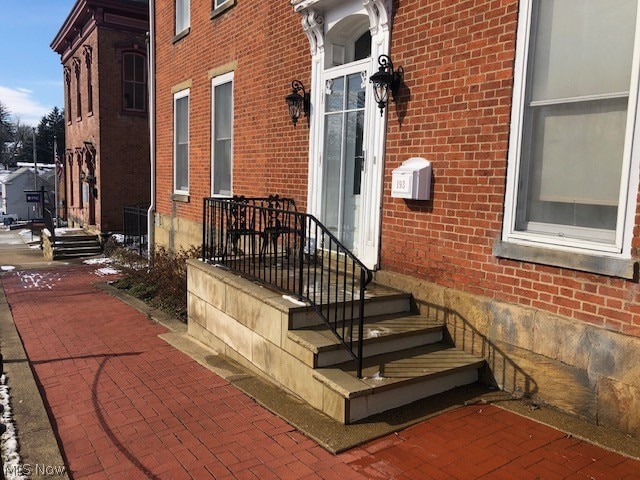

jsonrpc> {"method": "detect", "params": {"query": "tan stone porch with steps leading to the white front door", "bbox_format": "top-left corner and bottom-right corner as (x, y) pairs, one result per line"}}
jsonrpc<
(187, 260), (484, 424)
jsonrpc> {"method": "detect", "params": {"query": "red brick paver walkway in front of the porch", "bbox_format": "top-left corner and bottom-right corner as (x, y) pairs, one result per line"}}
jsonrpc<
(2, 267), (640, 480)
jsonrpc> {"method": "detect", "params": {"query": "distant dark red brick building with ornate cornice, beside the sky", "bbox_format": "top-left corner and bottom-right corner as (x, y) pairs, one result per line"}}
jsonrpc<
(51, 0), (150, 232)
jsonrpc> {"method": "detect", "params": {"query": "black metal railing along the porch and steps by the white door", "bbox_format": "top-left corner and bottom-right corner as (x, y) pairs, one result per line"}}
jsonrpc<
(202, 196), (373, 378)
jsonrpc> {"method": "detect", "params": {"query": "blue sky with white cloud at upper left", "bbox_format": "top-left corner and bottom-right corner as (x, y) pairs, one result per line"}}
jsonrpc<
(0, 0), (75, 127)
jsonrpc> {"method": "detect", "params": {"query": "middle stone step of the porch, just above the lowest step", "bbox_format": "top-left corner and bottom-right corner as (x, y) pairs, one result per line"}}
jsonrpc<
(287, 313), (443, 368)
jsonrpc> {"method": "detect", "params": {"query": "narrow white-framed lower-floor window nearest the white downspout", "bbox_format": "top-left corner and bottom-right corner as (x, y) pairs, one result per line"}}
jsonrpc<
(173, 89), (189, 194)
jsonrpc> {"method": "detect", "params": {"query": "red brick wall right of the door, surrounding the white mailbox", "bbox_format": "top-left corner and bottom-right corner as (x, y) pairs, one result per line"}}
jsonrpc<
(382, 0), (640, 336)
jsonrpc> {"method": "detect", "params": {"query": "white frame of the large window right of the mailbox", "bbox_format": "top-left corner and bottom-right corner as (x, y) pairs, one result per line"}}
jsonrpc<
(502, 0), (640, 258)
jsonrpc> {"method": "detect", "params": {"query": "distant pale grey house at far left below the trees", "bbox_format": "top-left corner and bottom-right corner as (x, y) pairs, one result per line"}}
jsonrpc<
(0, 167), (53, 220)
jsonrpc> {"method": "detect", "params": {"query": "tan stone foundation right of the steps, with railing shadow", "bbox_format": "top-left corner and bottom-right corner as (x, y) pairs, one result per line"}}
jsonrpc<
(375, 271), (640, 437)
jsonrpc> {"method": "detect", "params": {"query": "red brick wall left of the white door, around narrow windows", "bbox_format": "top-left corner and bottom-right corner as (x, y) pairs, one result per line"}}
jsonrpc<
(156, 0), (310, 227)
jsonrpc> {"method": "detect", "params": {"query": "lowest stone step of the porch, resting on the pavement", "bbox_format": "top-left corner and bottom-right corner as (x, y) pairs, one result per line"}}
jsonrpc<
(313, 343), (484, 423)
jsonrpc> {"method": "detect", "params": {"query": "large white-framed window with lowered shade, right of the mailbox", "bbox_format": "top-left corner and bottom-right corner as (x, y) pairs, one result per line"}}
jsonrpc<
(503, 0), (638, 255)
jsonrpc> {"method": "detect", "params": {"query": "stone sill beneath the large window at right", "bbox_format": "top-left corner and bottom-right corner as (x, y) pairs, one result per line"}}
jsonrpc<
(493, 241), (638, 282)
